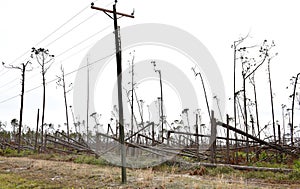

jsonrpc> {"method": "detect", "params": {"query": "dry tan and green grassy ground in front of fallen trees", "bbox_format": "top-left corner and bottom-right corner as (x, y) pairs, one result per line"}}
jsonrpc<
(0, 157), (300, 189)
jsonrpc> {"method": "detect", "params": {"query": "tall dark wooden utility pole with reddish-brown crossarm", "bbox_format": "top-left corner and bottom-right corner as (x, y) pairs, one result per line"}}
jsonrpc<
(91, 0), (134, 184)
